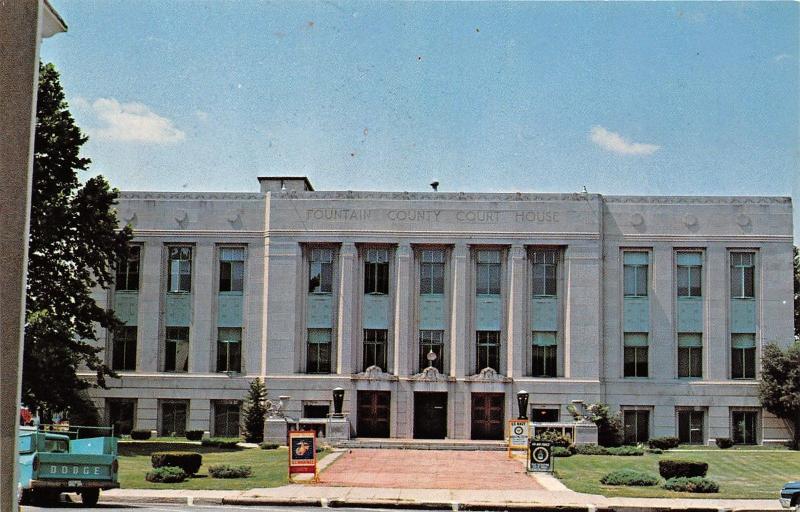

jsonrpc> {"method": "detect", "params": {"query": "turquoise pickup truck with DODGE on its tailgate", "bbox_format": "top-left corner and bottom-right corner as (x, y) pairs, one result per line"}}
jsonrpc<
(17, 426), (119, 506)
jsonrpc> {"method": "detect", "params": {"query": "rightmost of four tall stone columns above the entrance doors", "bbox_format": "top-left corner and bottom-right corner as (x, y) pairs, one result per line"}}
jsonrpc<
(506, 245), (527, 377)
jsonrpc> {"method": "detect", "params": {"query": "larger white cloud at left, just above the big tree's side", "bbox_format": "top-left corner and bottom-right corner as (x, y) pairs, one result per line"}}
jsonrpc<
(89, 98), (186, 144)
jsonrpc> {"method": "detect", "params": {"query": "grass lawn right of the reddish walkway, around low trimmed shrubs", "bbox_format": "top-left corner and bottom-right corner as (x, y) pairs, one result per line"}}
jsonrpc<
(555, 447), (800, 499)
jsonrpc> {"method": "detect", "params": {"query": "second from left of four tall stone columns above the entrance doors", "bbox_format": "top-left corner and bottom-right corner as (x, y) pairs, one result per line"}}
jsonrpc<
(393, 242), (414, 375)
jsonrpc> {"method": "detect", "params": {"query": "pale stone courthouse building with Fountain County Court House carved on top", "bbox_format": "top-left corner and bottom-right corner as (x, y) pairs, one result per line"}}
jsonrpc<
(84, 177), (793, 443)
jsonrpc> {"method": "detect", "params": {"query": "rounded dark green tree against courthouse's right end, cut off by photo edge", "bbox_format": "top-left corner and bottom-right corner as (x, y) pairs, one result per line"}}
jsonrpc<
(759, 341), (800, 450)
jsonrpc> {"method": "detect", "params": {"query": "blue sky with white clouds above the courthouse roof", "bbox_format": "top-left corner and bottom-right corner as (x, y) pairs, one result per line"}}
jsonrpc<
(42, 0), (800, 239)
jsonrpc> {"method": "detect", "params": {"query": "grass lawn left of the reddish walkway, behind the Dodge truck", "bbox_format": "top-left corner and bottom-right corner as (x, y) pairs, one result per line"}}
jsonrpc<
(119, 445), (329, 490)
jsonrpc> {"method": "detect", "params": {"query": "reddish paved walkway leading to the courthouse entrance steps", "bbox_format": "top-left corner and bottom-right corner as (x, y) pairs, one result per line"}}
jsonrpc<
(320, 449), (543, 490)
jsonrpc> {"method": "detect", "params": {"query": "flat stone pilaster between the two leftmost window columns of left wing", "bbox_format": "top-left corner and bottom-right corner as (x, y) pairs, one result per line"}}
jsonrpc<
(136, 240), (164, 373)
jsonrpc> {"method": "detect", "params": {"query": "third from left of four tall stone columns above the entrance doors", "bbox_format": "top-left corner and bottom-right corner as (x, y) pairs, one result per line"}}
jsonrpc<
(450, 244), (471, 377)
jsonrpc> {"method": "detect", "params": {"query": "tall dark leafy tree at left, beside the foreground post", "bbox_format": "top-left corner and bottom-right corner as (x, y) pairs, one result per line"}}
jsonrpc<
(22, 64), (131, 421)
